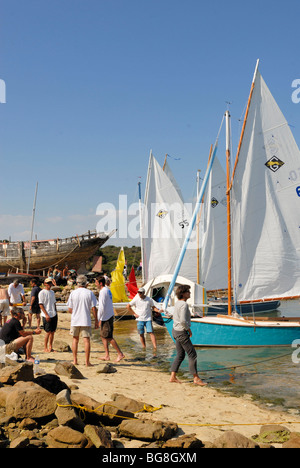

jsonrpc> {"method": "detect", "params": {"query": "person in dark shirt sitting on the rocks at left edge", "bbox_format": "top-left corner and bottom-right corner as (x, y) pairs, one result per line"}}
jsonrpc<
(0, 307), (41, 362)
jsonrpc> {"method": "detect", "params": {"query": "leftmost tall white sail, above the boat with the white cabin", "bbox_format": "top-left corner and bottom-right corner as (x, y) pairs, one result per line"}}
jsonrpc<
(142, 153), (196, 282)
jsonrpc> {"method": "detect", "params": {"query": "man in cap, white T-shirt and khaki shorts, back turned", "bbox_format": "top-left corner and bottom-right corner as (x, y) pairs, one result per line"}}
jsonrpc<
(67, 275), (98, 367)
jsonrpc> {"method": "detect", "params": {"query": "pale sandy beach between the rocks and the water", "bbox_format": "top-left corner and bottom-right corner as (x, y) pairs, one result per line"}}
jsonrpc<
(23, 312), (300, 447)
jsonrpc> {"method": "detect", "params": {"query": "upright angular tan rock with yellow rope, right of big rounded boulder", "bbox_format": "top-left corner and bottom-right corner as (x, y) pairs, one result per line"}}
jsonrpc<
(55, 390), (84, 432)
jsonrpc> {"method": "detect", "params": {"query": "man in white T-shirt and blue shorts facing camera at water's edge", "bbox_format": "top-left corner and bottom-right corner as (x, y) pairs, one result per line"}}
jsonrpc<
(127, 288), (162, 352)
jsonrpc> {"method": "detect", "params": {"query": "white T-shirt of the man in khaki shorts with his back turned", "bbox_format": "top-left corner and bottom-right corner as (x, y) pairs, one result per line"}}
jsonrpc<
(67, 287), (97, 327)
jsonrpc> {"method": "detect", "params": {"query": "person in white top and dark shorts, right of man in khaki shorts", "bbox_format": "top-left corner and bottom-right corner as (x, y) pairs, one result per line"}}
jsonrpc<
(96, 277), (125, 362)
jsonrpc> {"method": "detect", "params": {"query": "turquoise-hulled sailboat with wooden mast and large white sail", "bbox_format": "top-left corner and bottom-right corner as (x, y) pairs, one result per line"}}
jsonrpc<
(164, 62), (300, 347)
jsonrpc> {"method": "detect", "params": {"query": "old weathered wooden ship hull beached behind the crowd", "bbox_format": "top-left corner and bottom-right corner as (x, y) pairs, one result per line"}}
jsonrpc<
(0, 231), (115, 274)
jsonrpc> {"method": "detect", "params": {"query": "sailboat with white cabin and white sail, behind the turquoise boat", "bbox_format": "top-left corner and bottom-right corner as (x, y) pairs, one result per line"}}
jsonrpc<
(141, 151), (206, 315)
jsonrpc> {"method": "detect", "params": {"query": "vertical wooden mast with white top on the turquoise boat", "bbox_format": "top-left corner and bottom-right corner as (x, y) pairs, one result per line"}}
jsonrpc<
(225, 111), (232, 315)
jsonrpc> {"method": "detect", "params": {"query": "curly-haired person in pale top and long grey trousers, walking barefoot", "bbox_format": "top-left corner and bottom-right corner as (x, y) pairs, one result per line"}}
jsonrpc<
(170, 285), (207, 387)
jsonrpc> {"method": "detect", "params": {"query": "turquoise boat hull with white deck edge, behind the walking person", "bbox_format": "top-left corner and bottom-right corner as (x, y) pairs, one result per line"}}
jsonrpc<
(164, 316), (300, 348)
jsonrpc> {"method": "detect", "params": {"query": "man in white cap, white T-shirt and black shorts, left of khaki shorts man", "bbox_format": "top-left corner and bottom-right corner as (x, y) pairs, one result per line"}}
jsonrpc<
(39, 278), (57, 353)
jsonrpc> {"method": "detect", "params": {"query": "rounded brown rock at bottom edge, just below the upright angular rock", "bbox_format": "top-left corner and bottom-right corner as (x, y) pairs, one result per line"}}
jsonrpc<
(46, 426), (88, 448)
